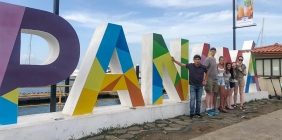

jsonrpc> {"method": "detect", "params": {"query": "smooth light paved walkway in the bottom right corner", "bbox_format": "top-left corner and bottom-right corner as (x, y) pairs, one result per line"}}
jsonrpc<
(193, 110), (282, 140)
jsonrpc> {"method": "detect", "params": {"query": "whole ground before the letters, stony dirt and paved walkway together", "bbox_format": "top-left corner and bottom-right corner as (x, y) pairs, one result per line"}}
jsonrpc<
(85, 99), (282, 140)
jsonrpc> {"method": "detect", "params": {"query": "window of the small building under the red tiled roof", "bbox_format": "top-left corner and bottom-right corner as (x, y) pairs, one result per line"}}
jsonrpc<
(256, 58), (282, 77)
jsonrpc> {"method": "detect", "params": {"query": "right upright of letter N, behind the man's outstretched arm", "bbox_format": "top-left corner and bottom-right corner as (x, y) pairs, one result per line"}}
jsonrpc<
(170, 39), (189, 100)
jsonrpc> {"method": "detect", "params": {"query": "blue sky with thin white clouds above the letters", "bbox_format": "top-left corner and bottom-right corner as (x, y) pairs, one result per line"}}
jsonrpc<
(0, 0), (282, 69)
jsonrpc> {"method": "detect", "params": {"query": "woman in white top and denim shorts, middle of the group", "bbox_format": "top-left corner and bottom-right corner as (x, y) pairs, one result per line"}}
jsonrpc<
(217, 56), (228, 113)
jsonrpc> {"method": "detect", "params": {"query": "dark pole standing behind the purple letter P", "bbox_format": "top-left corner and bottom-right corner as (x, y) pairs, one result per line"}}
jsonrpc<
(50, 0), (59, 112)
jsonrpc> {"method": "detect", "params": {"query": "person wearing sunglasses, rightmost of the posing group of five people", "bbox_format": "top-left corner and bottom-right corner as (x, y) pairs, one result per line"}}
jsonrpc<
(234, 56), (247, 110)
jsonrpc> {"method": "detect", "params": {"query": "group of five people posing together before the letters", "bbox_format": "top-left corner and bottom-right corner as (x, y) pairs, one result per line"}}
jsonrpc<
(172, 48), (246, 118)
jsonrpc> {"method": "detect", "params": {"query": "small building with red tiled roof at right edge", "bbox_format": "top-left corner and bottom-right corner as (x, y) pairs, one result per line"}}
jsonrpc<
(244, 43), (282, 95)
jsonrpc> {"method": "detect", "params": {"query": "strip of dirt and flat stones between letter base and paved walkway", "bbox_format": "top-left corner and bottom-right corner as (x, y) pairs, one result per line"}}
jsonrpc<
(81, 99), (282, 140)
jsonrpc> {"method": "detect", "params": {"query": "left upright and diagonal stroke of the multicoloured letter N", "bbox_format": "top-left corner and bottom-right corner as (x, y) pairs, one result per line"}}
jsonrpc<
(141, 33), (184, 104)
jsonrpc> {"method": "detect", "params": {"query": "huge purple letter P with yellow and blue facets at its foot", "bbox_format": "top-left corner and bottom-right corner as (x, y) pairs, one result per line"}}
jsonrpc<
(0, 2), (79, 125)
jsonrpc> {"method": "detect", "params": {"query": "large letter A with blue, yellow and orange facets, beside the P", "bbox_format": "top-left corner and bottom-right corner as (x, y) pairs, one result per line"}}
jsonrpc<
(63, 24), (145, 115)
